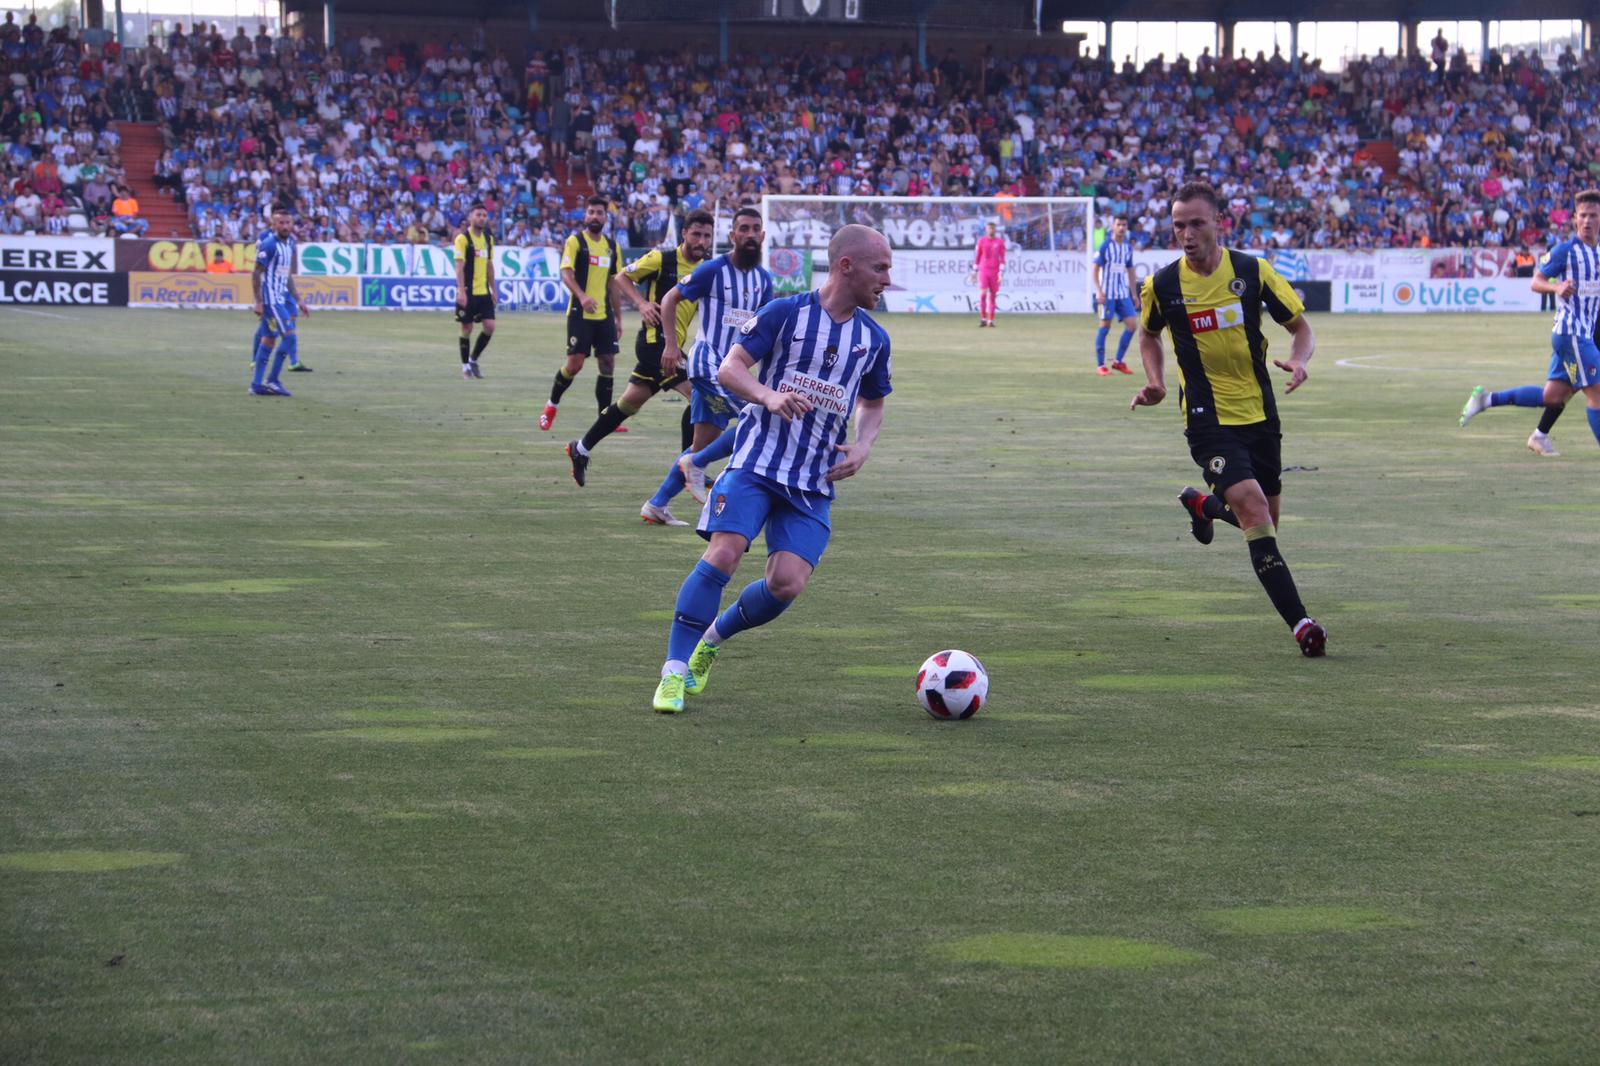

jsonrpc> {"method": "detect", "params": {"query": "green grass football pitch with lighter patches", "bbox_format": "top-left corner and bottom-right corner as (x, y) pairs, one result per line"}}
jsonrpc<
(0, 302), (1600, 1064)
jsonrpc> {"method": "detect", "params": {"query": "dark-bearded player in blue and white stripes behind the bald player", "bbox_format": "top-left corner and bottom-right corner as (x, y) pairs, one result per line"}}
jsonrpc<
(638, 206), (773, 525)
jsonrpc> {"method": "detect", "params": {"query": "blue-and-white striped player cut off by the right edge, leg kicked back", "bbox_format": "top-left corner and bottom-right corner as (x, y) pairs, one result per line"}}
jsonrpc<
(1461, 189), (1600, 456)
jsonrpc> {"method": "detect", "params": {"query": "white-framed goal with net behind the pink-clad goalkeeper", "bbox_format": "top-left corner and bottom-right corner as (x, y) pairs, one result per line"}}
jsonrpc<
(762, 195), (1094, 314)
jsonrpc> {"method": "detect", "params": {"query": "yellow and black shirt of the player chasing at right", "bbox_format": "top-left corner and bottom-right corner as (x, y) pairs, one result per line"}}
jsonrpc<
(1141, 248), (1306, 427)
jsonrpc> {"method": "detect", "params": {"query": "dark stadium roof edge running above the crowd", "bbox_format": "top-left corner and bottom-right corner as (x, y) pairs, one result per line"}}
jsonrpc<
(286, 0), (1600, 37)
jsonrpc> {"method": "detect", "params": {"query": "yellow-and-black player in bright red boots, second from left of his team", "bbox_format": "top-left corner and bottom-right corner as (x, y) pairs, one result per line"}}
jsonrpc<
(539, 195), (622, 431)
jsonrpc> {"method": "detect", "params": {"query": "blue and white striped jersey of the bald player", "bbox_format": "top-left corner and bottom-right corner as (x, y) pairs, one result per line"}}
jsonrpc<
(728, 293), (890, 498)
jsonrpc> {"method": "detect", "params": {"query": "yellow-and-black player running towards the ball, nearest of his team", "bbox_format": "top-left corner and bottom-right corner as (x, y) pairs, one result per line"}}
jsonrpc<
(1130, 181), (1328, 656)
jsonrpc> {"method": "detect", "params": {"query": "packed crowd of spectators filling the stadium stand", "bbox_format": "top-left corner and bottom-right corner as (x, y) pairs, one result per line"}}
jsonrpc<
(0, 16), (1600, 248)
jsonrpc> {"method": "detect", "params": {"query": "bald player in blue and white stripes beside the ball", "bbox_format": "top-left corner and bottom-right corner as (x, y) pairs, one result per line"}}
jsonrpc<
(654, 226), (890, 714)
